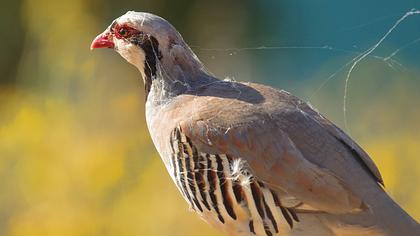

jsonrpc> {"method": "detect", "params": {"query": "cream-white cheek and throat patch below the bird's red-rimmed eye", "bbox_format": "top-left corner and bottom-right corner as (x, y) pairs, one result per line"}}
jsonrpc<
(114, 39), (145, 73)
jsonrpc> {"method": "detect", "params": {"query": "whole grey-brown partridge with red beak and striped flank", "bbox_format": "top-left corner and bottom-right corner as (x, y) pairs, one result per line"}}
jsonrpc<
(91, 11), (420, 236)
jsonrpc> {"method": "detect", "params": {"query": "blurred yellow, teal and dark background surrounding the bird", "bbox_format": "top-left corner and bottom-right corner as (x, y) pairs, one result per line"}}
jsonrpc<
(0, 0), (420, 236)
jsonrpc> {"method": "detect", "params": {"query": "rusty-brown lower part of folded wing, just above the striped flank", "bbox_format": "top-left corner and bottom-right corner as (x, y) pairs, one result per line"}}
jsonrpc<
(181, 122), (362, 213)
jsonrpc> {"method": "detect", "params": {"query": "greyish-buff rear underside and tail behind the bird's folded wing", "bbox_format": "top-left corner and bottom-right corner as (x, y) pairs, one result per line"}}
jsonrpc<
(292, 194), (420, 236)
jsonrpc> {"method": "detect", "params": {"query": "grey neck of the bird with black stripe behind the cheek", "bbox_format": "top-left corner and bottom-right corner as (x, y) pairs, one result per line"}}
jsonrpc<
(139, 36), (217, 105)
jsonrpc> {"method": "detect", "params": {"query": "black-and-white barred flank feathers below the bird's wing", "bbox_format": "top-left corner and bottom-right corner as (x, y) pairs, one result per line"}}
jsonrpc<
(170, 128), (299, 235)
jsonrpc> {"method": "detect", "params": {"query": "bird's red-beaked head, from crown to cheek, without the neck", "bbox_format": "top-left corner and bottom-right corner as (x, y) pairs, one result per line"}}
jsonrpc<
(91, 11), (178, 74)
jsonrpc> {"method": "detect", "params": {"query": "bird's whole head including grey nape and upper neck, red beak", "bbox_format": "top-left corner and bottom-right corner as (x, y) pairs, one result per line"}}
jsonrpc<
(90, 11), (208, 96)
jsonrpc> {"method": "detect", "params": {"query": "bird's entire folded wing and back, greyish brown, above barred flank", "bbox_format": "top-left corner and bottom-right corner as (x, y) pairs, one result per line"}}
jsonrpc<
(172, 81), (382, 213)
